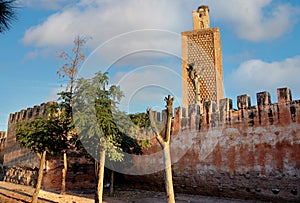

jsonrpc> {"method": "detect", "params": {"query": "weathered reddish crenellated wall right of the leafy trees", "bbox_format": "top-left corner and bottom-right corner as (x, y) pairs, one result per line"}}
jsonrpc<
(125, 88), (300, 201)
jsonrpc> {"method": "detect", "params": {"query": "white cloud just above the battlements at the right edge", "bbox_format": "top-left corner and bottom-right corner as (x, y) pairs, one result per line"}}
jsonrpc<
(225, 55), (300, 101)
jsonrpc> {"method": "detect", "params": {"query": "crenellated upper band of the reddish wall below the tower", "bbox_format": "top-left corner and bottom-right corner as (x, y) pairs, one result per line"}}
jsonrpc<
(149, 88), (300, 130)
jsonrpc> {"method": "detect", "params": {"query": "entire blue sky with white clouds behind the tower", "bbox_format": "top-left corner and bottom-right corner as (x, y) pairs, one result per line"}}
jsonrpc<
(0, 0), (300, 130)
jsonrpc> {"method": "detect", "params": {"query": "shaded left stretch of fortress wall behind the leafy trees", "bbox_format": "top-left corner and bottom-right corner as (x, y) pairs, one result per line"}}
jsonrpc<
(0, 102), (94, 190)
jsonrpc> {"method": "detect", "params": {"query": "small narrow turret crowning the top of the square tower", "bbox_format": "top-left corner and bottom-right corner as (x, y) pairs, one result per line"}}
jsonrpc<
(193, 5), (210, 30)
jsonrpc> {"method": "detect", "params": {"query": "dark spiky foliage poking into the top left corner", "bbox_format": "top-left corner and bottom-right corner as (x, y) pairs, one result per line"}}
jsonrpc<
(0, 0), (16, 33)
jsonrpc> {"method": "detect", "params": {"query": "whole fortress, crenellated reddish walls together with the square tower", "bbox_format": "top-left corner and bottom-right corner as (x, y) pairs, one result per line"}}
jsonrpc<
(0, 2), (300, 202)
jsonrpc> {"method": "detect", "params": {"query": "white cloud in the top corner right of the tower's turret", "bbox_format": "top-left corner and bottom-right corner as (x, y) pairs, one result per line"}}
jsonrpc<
(206, 0), (299, 42)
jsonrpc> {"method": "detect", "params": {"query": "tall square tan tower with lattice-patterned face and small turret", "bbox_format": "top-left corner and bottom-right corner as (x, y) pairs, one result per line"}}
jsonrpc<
(181, 6), (224, 107)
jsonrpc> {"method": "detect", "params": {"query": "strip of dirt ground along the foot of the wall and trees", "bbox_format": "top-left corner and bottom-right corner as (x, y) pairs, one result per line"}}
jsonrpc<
(0, 181), (268, 203)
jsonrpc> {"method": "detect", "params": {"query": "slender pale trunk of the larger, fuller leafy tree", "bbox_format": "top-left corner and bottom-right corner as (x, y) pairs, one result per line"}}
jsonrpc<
(95, 141), (105, 203)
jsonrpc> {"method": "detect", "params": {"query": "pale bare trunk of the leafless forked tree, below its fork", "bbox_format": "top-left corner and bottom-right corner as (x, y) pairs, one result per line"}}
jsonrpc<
(163, 145), (175, 203)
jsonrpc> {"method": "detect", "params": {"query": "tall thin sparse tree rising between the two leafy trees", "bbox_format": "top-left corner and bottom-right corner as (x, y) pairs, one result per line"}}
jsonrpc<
(57, 36), (87, 195)
